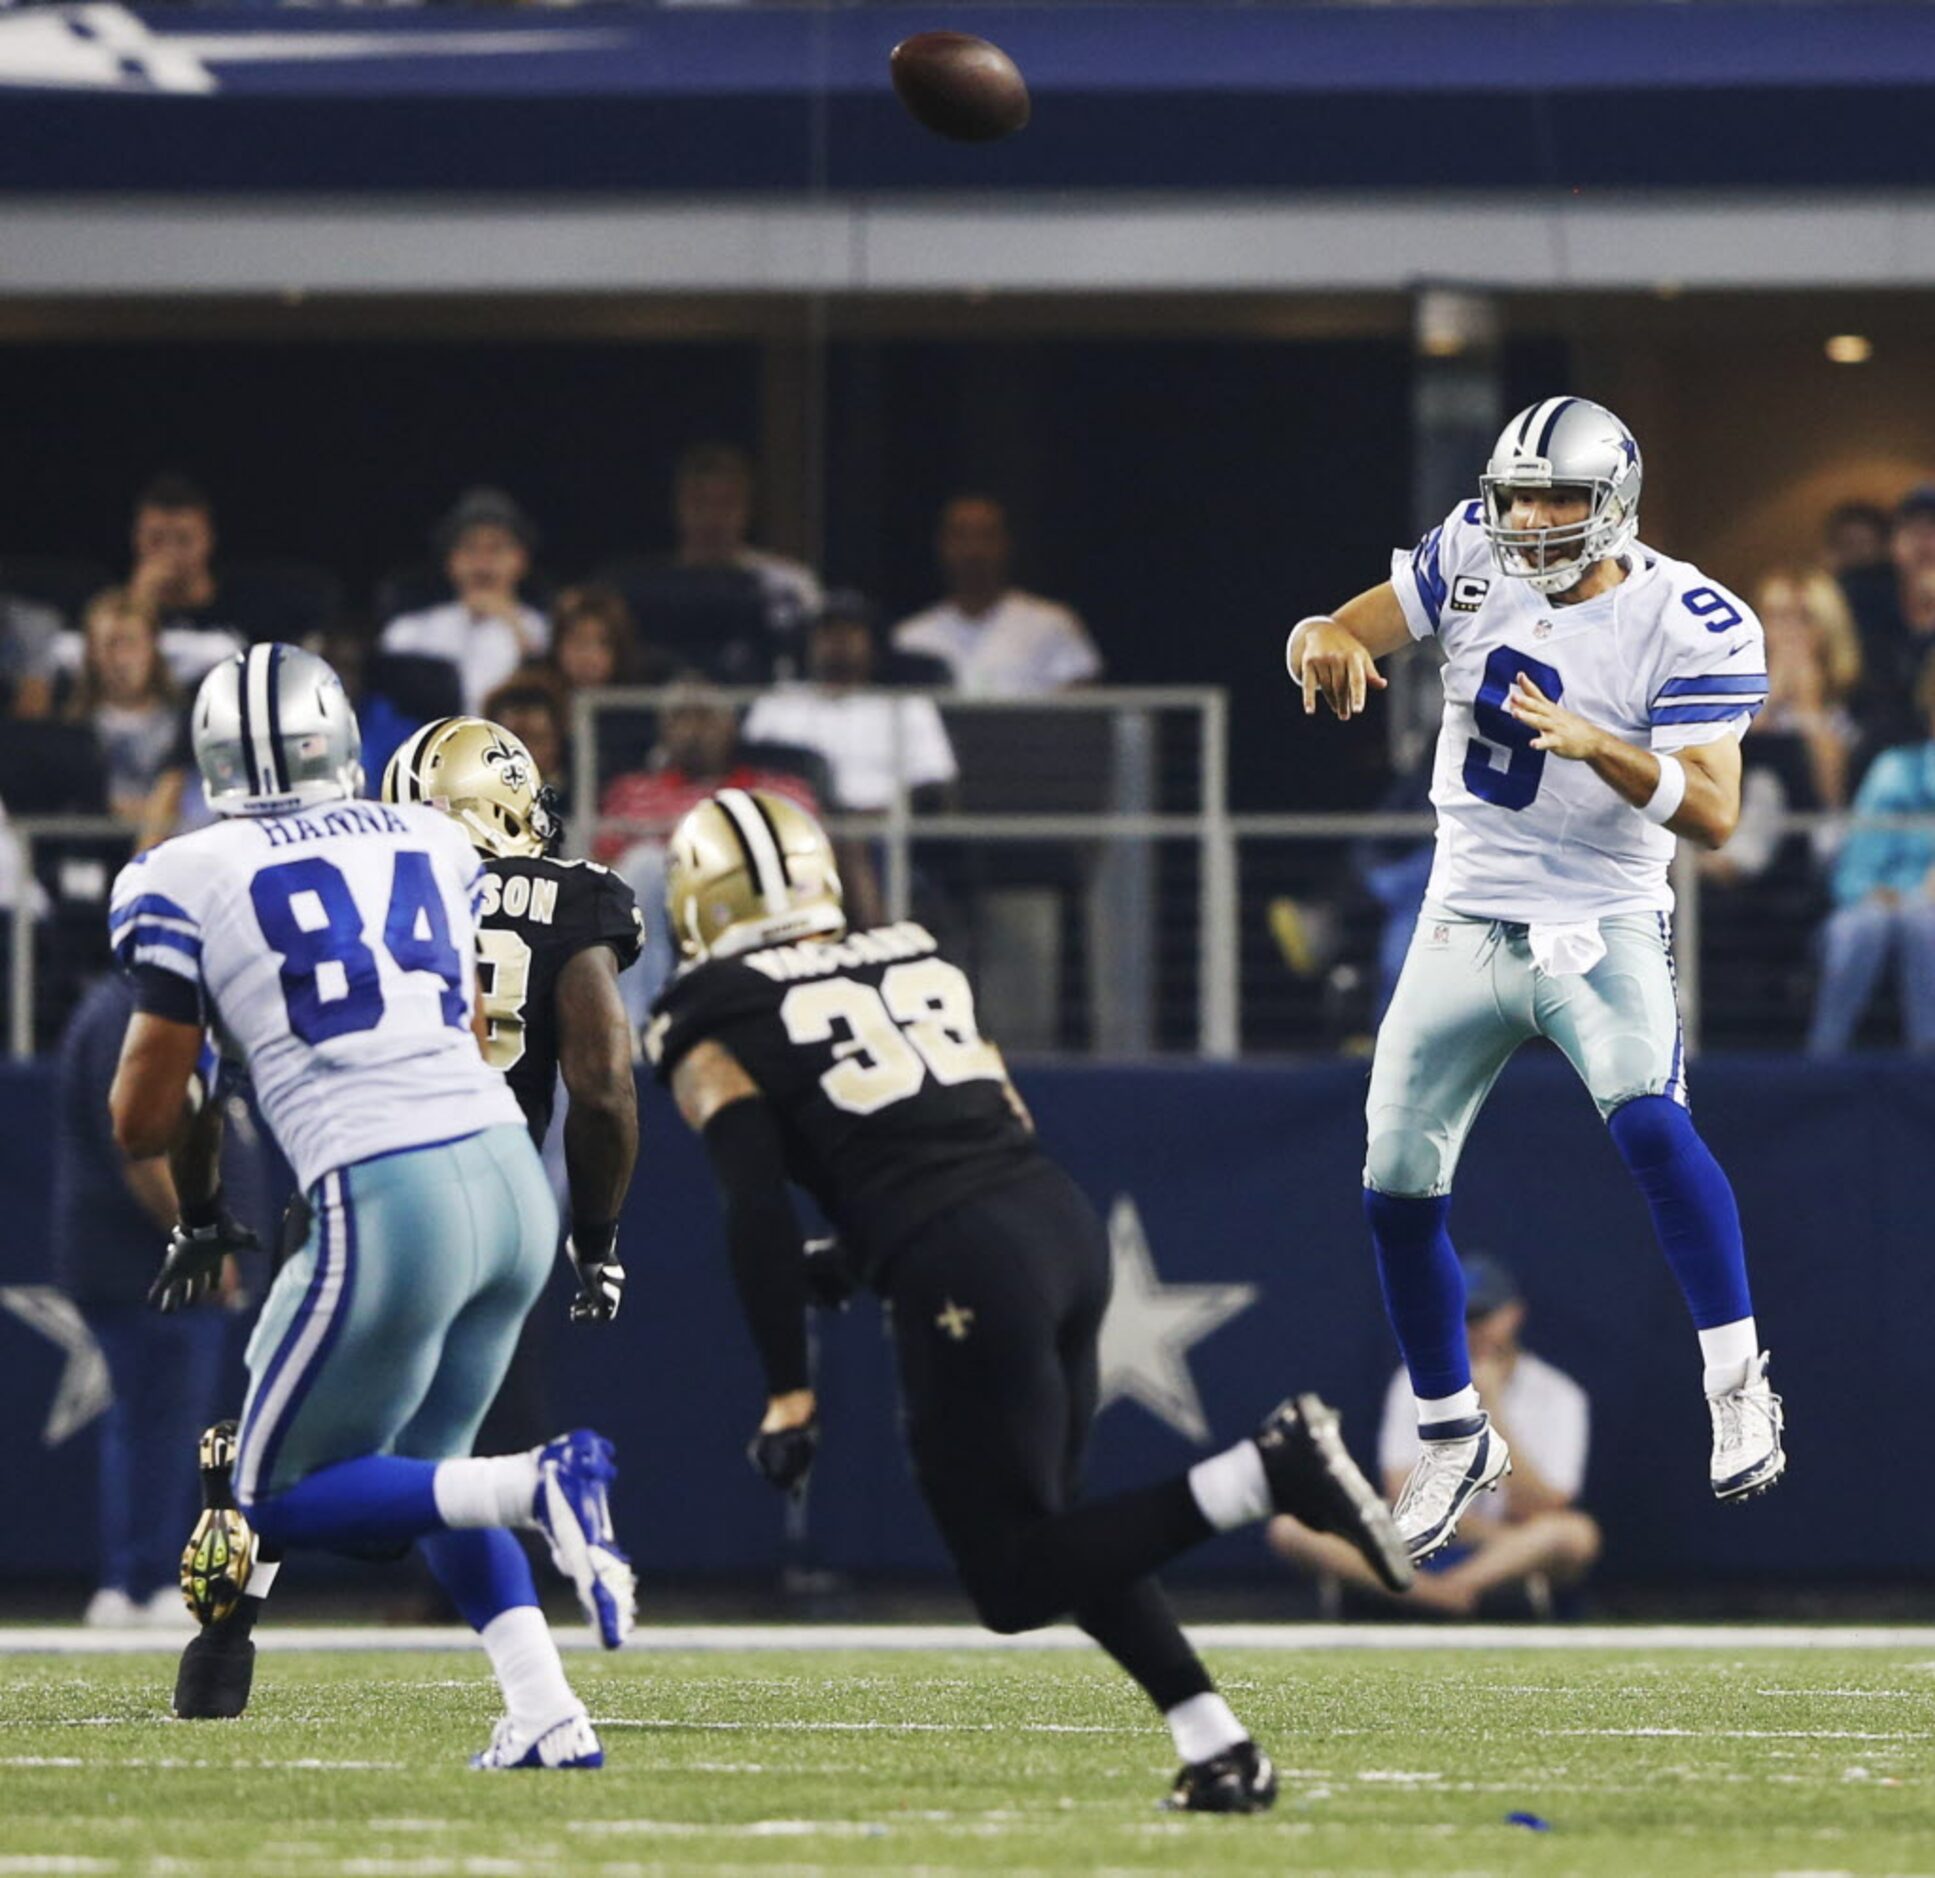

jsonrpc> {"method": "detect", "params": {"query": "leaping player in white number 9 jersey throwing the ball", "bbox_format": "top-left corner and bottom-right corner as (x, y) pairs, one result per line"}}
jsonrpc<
(1285, 398), (1786, 1559)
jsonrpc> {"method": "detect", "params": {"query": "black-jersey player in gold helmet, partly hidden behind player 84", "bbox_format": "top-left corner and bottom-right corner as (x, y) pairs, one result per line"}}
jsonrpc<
(174, 718), (644, 1719)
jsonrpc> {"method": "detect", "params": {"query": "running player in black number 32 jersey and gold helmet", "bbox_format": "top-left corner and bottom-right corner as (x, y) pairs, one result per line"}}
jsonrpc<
(646, 789), (1411, 1812)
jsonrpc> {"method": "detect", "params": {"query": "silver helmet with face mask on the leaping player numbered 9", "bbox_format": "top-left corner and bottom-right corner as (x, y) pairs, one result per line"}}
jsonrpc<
(1478, 398), (1645, 594)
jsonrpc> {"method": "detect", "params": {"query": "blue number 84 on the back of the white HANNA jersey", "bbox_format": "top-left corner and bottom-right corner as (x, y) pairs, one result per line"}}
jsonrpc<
(248, 847), (470, 1044)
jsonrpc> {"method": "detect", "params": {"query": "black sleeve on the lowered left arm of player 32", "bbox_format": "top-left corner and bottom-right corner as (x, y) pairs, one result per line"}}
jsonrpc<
(702, 1097), (809, 1394)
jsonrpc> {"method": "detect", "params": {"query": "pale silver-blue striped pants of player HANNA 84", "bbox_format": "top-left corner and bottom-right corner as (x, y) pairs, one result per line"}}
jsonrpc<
(236, 1126), (557, 1507)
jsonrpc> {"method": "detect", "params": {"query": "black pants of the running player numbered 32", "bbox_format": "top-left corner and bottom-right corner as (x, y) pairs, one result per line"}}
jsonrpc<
(886, 1166), (1211, 1710)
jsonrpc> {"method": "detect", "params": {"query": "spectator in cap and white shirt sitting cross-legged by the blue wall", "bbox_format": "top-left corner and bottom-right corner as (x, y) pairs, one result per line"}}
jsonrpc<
(1267, 1251), (1600, 1617)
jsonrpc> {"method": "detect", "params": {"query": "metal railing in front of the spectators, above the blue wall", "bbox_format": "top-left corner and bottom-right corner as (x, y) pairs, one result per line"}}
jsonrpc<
(0, 727), (1935, 1060)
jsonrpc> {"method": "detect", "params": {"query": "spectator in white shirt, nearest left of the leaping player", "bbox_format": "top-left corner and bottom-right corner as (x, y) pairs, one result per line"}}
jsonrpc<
(894, 495), (1101, 698)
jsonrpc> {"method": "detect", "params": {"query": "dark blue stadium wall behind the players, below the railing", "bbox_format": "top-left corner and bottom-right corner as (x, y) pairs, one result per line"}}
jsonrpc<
(0, 1054), (1935, 1580)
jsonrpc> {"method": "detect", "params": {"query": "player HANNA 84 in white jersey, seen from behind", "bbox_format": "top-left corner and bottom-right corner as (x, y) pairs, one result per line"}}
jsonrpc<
(108, 644), (633, 1768)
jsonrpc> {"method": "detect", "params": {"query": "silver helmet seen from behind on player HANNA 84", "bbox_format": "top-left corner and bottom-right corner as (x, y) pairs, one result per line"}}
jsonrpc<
(190, 644), (362, 814)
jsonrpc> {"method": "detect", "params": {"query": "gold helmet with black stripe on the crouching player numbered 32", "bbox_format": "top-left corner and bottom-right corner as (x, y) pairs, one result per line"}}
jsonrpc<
(666, 789), (846, 959)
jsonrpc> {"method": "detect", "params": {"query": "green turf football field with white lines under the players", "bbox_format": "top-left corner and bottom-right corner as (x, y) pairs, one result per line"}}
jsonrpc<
(0, 1632), (1935, 1878)
